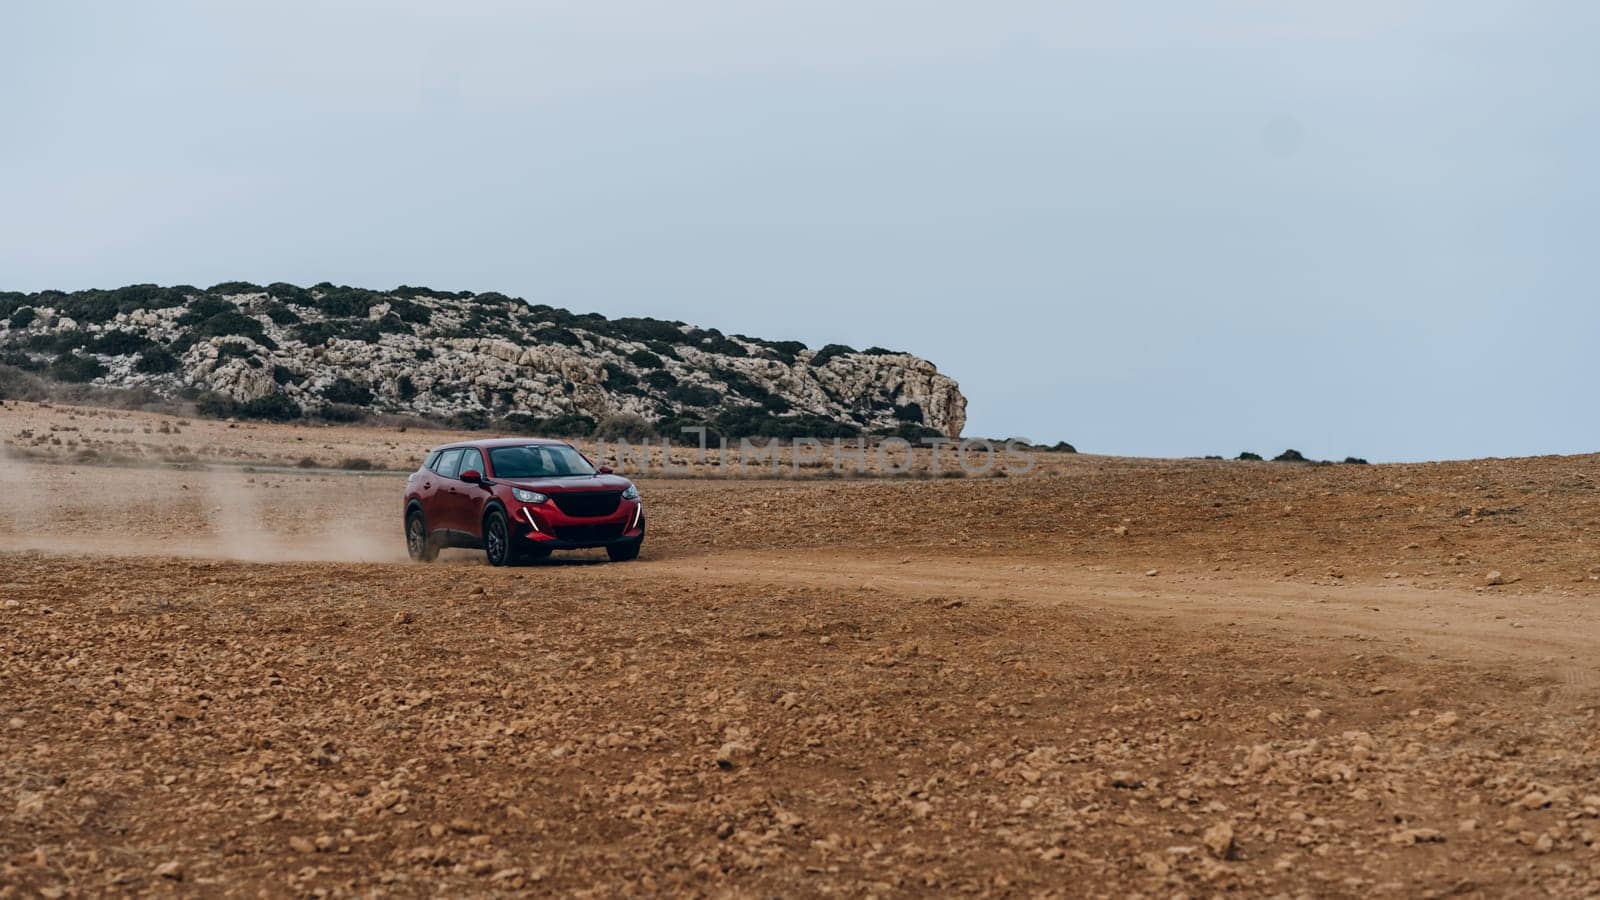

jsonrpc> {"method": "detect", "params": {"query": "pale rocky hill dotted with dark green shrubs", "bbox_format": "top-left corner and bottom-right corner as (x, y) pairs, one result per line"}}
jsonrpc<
(0, 282), (966, 437)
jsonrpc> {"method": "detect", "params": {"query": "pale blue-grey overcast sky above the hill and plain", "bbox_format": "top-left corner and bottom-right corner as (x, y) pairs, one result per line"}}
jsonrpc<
(0, 0), (1600, 461)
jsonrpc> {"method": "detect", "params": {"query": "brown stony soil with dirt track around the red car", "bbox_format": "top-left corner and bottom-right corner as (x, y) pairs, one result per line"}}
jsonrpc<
(9, 407), (1600, 897)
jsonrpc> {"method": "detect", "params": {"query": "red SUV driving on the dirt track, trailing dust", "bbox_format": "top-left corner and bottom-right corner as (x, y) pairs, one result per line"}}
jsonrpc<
(405, 437), (645, 565)
